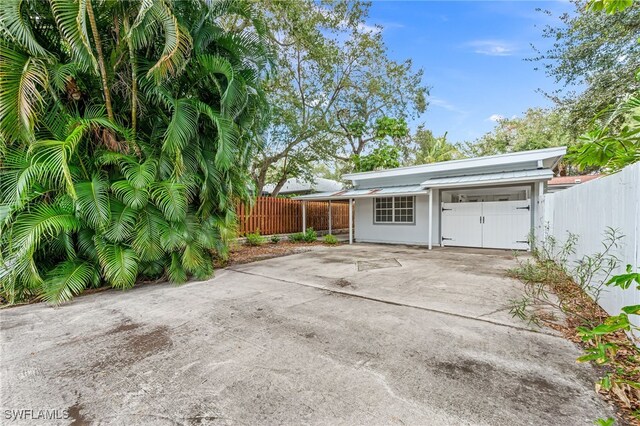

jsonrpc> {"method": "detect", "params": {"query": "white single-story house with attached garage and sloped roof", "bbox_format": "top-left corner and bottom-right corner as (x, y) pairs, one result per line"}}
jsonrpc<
(296, 147), (566, 250)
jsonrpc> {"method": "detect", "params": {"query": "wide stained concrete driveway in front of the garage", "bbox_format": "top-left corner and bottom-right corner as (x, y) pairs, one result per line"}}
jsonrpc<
(0, 244), (612, 425)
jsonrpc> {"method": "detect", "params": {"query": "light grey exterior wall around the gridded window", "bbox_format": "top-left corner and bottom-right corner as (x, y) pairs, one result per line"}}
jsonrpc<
(354, 191), (440, 246)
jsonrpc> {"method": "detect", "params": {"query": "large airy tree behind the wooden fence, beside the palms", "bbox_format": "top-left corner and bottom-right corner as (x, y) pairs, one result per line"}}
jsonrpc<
(253, 0), (426, 193)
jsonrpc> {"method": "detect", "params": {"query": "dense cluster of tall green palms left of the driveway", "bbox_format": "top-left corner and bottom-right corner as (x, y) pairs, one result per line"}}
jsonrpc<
(0, 0), (270, 303)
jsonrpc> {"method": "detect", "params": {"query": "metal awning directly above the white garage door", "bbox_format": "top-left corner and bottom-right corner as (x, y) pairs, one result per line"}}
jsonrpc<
(421, 169), (553, 188)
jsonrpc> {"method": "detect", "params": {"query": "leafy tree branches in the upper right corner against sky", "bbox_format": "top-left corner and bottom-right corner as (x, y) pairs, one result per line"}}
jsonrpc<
(533, 0), (640, 136)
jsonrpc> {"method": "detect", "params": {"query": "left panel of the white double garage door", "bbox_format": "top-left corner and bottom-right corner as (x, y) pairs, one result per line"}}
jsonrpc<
(442, 203), (482, 247)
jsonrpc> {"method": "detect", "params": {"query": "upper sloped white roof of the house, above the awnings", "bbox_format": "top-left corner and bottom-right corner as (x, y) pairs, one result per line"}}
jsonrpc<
(343, 147), (567, 186)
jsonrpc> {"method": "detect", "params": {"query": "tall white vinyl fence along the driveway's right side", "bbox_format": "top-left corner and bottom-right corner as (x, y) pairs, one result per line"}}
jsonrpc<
(544, 163), (640, 337)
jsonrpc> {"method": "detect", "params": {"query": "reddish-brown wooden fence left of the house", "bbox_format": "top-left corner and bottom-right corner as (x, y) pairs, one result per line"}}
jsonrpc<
(236, 197), (349, 235)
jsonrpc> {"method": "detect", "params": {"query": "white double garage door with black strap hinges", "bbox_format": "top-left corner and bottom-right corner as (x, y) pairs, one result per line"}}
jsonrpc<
(442, 200), (531, 250)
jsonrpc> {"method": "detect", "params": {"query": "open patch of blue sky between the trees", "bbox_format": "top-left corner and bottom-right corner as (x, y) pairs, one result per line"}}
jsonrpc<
(368, 1), (573, 142)
